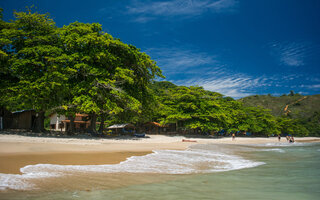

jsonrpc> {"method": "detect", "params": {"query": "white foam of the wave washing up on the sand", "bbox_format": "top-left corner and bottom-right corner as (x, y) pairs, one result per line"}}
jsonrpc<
(0, 149), (264, 190)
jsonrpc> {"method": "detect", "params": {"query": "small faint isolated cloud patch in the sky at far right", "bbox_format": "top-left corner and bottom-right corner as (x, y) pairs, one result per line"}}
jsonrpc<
(270, 42), (312, 67)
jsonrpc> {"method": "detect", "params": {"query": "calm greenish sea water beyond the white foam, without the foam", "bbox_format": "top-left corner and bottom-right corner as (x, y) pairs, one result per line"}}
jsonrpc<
(1, 144), (320, 200)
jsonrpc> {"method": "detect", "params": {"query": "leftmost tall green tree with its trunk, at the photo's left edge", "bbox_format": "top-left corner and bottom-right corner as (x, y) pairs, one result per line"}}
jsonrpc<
(1, 9), (67, 132)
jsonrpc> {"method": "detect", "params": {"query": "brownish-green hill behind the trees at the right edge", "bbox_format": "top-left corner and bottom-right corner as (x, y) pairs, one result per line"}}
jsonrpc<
(238, 93), (320, 119)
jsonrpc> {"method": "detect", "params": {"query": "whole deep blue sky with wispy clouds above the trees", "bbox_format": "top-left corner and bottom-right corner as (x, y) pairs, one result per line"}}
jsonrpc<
(0, 0), (320, 99)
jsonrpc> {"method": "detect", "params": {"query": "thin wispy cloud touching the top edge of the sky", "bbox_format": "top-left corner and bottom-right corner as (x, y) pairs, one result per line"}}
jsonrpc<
(127, 0), (239, 23)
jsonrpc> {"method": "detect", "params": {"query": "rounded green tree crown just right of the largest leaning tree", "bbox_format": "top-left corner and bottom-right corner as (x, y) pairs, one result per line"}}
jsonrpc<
(153, 86), (229, 134)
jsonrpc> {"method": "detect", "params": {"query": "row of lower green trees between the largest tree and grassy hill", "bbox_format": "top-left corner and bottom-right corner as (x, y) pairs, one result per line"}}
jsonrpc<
(150, 83), (279, 135)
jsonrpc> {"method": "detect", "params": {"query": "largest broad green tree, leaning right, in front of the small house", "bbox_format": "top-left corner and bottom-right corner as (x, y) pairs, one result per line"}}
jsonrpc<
(59, 22), (162, 133)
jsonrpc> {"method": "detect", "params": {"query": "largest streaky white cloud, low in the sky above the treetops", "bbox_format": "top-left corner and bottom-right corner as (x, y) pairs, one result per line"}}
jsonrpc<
(146, 46), (320, 99)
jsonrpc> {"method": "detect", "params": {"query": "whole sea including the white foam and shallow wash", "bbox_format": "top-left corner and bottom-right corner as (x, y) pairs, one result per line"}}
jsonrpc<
(0, 143), (320, 200)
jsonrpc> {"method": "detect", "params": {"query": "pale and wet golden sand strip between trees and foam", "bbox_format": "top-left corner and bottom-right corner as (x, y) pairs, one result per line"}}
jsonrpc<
(0, 135), (320, 174)
